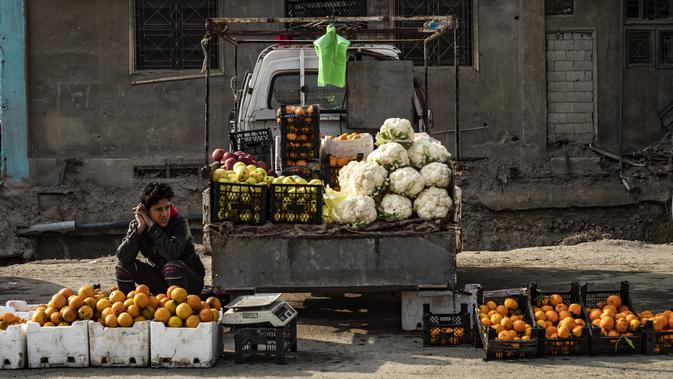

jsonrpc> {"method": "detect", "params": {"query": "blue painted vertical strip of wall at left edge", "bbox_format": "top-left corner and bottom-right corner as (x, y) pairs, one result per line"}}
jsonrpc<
(0, 0), (28, 179)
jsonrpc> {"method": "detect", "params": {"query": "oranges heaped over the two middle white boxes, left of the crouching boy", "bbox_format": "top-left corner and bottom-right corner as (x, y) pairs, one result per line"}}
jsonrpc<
(32, 284), (159, 328)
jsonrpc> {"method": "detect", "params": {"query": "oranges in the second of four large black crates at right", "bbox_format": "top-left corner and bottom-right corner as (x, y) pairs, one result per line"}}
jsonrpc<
(533, 294), (586, 339)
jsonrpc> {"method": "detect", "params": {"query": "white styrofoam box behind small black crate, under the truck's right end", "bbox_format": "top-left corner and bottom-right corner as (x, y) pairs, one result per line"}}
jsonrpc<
(402, 284), (481, 330)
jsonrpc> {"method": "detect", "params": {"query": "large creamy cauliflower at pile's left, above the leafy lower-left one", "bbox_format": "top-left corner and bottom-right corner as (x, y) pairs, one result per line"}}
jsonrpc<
(339, 162), (388, 196)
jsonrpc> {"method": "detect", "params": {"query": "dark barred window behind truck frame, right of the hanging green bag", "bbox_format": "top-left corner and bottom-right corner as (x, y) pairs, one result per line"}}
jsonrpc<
(395, 0), (473, 66)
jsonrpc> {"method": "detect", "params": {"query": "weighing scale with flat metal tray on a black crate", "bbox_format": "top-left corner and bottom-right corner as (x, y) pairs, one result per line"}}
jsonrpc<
(222, 293), (297, 328)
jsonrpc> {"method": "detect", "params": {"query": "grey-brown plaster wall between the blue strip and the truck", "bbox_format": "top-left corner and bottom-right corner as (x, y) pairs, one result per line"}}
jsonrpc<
(27, 0), (229, 186)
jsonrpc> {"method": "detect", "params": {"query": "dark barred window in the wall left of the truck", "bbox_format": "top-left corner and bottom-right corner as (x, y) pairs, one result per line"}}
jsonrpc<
(135, 0), (218, 70)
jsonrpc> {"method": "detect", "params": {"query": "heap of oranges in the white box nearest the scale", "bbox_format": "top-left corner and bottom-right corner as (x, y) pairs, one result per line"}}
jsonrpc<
(154, 286), (222, 328)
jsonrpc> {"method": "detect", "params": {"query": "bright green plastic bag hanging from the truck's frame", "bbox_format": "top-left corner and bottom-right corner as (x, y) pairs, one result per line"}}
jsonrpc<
(313, 25), (351, 87)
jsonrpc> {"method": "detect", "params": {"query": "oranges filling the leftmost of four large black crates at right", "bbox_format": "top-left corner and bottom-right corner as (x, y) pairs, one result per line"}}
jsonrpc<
(479, 298), (533, 341)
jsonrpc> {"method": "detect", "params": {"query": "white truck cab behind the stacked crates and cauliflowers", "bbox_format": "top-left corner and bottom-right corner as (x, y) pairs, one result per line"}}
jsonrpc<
(230, 44), (426, 137)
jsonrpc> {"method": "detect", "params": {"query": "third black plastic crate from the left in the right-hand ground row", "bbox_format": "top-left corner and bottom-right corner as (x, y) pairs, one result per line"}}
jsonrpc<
(581, 281), (643, 355)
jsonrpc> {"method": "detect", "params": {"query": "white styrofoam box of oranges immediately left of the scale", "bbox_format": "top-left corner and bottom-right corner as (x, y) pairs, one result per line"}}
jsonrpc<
(150, 321), (223, 367)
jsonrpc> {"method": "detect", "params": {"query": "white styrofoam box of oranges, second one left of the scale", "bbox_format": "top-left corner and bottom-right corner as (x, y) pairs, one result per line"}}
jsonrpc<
(89, 321), (150, 367)
